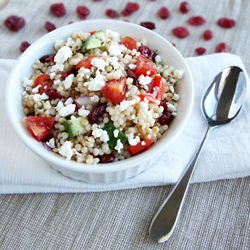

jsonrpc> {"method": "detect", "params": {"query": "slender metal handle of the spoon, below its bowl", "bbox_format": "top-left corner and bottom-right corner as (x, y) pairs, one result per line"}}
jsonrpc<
(149, 126), (210, 243)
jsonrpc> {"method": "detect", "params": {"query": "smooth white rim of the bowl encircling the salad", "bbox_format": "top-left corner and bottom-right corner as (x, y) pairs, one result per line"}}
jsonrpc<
(5, 19), (194, 174)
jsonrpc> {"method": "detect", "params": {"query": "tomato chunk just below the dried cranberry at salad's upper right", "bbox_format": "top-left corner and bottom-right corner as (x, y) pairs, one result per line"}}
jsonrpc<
(134, 55), (157, 76)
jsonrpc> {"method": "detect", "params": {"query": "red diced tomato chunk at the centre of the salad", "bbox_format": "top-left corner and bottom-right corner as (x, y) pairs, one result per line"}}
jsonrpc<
(101, 77), (127, 104)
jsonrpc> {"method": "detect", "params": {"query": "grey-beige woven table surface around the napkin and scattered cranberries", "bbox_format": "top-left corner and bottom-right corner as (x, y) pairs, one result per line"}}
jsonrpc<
(0, 0), (250, 249)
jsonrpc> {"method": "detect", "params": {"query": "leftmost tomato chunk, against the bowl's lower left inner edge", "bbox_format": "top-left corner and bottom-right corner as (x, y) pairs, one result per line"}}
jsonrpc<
(24, 116), (55, 141)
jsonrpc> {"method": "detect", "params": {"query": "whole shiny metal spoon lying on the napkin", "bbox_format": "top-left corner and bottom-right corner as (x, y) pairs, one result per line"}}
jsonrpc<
(149, 66), (246, 243)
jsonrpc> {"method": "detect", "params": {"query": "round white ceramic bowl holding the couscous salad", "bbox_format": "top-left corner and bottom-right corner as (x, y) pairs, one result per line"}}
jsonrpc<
(6, 20), (194, 184)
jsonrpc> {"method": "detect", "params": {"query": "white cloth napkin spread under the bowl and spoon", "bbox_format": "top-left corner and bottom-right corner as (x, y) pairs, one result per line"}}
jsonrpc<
(0, 54), (250, 194)
